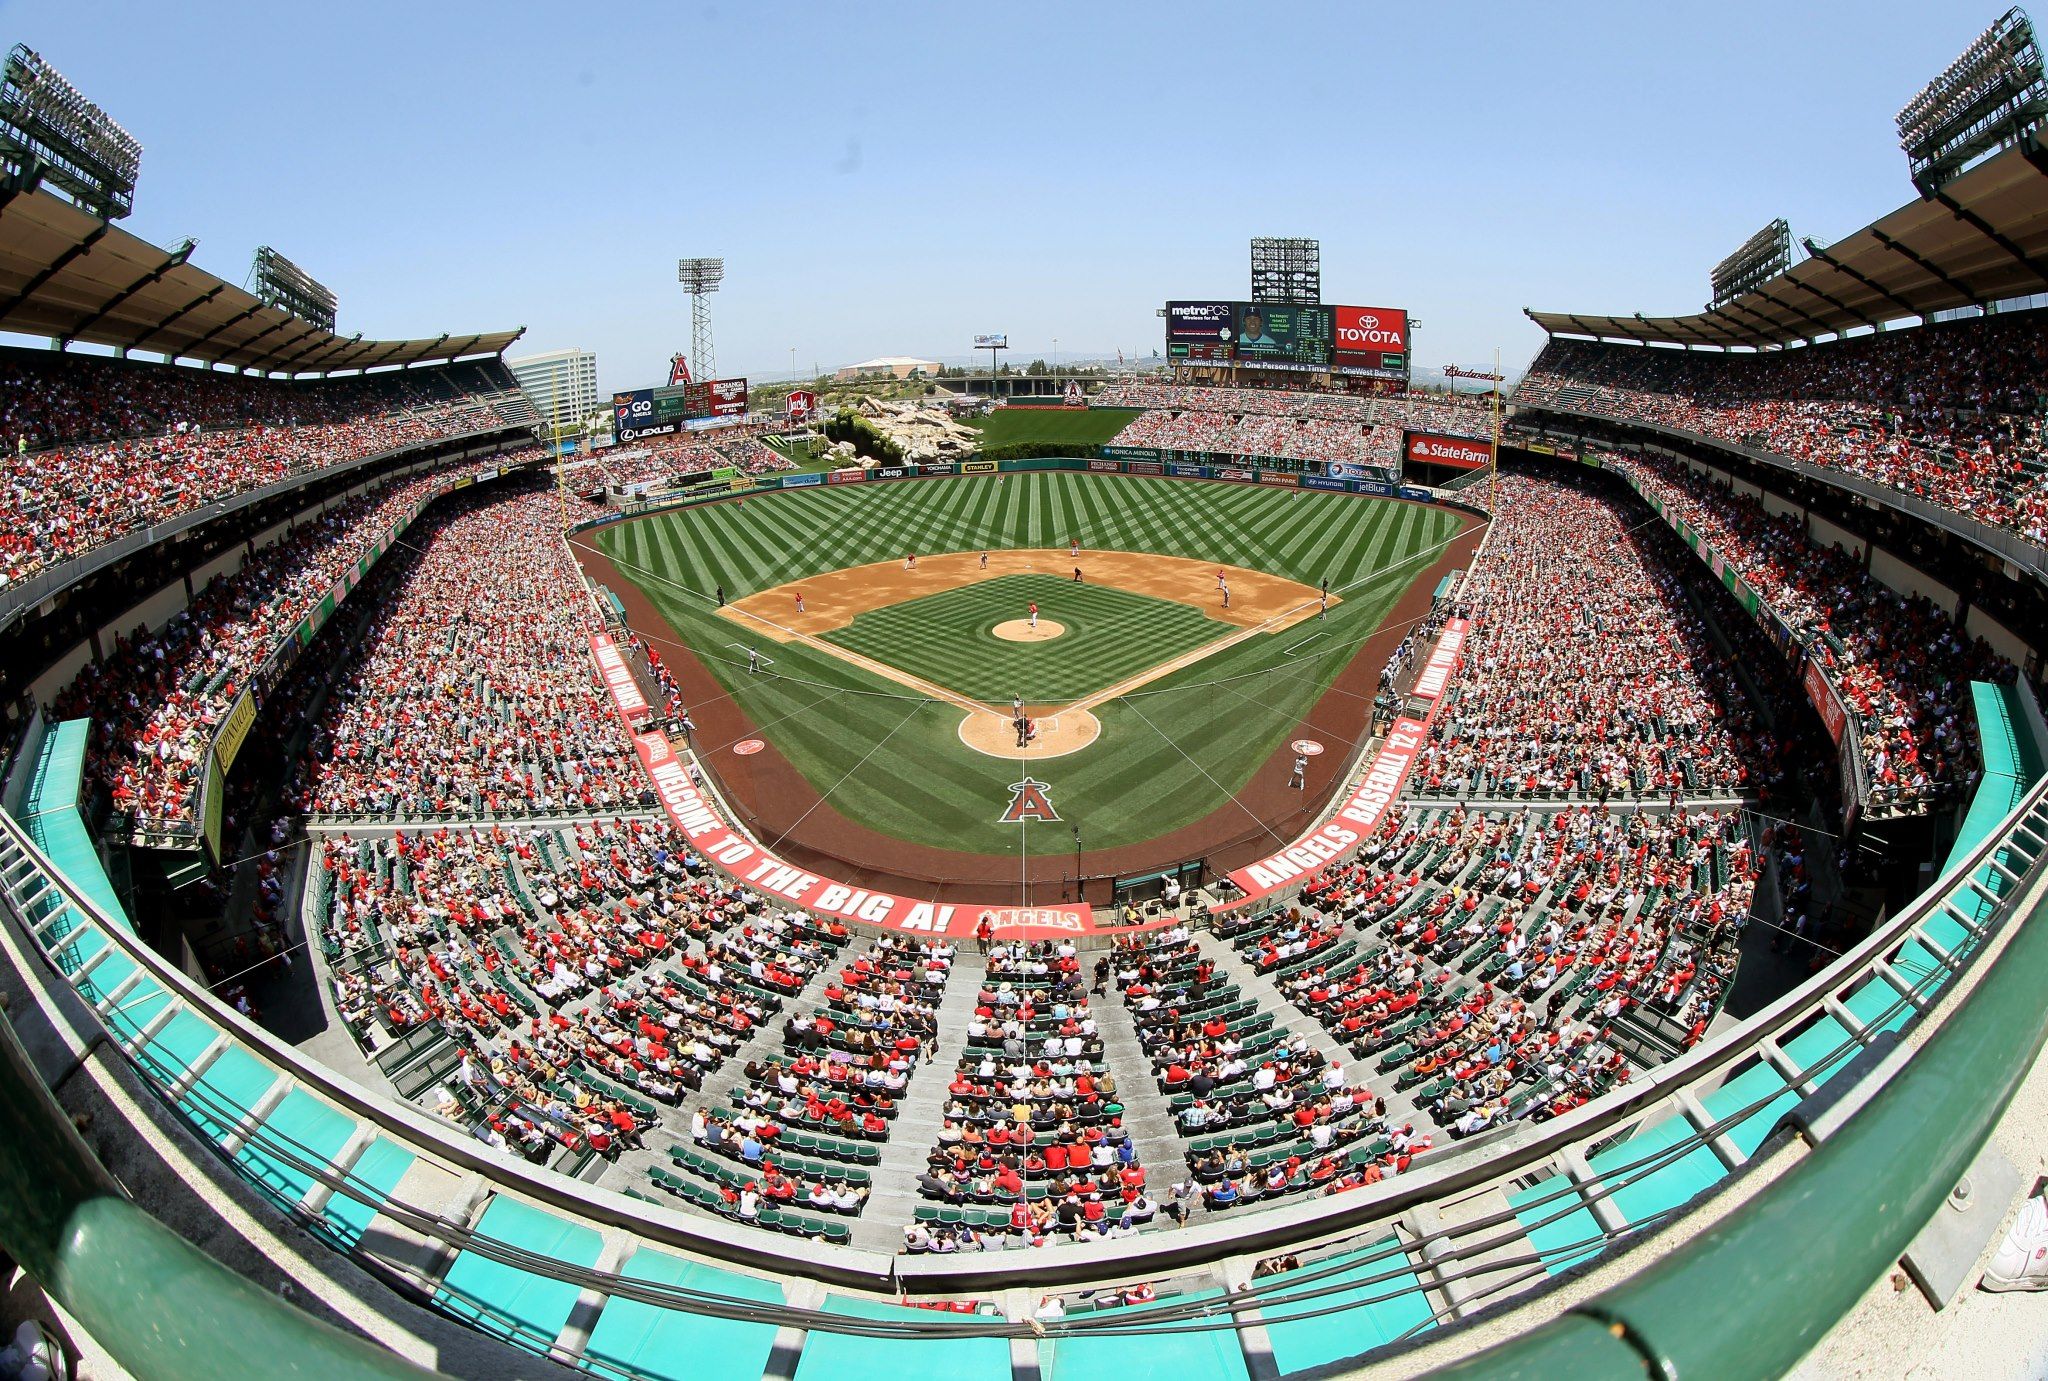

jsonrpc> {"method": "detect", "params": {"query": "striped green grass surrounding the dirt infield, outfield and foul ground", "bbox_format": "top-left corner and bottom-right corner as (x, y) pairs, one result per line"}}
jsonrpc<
(596, 471), (1458, 852)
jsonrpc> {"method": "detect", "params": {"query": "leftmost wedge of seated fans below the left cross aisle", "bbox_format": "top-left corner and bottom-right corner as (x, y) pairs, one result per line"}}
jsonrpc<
(307, 820), (846, 1192)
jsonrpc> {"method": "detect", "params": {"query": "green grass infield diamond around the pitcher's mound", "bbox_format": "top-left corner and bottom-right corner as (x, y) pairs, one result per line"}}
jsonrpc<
(825, 576), (1237, 705)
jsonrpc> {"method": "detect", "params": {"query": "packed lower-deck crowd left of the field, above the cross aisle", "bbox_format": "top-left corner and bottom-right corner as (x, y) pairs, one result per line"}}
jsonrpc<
(287, 494), (651, 818)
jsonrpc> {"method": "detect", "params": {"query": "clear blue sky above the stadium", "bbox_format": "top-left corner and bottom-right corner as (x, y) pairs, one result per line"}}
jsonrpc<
(0, 0), (2001, 389)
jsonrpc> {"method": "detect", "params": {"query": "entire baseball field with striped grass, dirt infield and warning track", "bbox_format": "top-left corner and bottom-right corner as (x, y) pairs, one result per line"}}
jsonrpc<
(575, 471), (1470, 881)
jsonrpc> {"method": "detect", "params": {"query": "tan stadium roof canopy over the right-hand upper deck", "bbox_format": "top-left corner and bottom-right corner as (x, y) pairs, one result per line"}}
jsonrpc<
(1524, 135), (2048, 348)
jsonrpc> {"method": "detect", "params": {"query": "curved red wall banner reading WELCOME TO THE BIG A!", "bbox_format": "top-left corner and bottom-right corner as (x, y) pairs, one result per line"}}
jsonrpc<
(633, 731), (1096, 940)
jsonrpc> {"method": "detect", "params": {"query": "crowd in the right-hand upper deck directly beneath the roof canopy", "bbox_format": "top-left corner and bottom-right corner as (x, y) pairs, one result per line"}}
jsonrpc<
(1513, 313), (2048, 543)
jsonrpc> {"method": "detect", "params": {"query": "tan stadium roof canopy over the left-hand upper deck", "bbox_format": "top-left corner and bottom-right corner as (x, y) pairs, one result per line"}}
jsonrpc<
(0, 189), (526, 375)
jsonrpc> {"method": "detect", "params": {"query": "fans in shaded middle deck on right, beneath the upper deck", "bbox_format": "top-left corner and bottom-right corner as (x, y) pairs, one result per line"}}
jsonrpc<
(1604, 455), (2017, 811)
